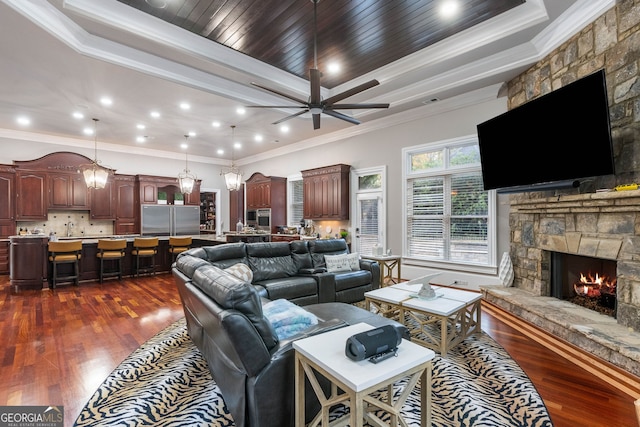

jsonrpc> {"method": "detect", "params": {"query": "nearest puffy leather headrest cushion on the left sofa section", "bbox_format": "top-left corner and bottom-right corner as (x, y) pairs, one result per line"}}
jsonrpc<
(193, 265), (278, 350)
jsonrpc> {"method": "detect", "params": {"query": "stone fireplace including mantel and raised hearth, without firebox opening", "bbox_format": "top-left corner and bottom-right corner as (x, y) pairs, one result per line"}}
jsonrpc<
(482, 190), (640, 375)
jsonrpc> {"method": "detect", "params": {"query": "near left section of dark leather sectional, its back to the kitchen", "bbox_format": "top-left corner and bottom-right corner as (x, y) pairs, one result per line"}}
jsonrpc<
(172, 246), (408, 427)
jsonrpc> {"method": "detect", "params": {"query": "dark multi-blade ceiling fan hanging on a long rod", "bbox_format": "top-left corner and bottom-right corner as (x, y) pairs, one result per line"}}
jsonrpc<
(247, 0), (389, 129)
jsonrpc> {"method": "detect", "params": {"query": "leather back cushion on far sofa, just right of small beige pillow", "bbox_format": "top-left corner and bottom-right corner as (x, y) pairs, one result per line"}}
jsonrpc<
(246, 242), (298, 283)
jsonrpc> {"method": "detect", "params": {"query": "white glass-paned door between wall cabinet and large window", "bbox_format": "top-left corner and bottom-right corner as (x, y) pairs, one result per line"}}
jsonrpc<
(353, 192), (384, 255)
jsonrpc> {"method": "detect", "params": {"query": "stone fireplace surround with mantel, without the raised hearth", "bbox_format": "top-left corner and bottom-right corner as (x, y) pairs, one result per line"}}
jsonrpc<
(509, 190), (640, 331)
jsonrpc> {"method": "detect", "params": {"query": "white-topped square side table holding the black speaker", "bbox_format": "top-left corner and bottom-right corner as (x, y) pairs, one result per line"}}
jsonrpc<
(293, 323), (435, 427)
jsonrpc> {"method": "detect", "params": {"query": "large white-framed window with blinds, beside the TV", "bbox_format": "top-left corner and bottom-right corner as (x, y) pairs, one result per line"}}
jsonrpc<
(403, 137), (496, 272)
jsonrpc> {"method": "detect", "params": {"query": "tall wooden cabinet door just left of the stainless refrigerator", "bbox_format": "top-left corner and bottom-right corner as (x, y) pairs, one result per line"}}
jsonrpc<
(113, 175), (140, 234)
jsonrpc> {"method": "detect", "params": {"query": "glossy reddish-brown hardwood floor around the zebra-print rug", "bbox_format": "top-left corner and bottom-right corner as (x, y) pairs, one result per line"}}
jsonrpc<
(0, 274), (640, 427)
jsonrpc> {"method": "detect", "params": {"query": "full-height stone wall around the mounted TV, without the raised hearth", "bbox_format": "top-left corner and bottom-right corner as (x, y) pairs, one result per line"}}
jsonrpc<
(508, 0), (640, 330)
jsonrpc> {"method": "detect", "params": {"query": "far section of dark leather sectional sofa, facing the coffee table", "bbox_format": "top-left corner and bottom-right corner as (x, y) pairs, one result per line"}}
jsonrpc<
(178, 239), (380, 306)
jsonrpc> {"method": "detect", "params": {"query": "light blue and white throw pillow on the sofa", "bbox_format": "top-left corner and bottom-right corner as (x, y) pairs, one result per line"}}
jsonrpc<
(262, 299), (318, 340)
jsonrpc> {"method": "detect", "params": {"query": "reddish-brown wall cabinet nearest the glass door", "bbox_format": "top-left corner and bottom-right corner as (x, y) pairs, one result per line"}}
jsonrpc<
(302, 164), (351, 220)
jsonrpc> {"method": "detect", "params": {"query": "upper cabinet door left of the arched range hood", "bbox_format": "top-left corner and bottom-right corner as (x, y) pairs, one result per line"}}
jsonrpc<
(16, 170), (47, 221)
